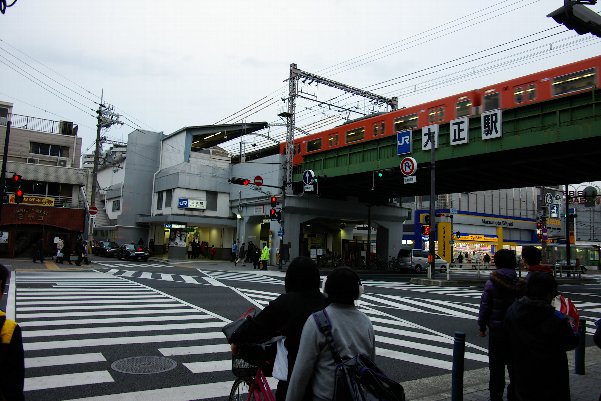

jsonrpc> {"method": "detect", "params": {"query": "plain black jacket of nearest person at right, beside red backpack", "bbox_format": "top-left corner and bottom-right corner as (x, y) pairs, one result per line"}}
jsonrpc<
(505, 297), (578, 401)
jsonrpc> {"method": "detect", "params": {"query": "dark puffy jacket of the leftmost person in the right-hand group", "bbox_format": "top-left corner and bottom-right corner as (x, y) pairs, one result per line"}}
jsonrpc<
(478, 268), (520, 332)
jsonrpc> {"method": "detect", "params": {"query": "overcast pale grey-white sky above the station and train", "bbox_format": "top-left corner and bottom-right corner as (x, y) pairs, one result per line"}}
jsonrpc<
(0, 0), (601, 152)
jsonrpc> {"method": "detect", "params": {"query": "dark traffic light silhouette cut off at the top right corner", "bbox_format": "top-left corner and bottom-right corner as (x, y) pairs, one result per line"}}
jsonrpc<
(547, 0), (601, 37)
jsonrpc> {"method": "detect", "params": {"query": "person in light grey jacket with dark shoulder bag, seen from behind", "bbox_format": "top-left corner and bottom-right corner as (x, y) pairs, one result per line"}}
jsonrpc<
(286, 267), (404, 401)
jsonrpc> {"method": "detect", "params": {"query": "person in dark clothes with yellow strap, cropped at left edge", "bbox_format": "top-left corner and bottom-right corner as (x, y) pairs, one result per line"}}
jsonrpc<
(0, 264), (25, 401)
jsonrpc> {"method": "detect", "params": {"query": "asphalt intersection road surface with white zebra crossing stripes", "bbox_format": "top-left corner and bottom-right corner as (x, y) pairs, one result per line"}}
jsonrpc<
(2, 258), (601, 401)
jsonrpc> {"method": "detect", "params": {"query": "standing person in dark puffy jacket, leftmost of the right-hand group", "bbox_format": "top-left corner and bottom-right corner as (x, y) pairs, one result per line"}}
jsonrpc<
(478, 249), (520, 401)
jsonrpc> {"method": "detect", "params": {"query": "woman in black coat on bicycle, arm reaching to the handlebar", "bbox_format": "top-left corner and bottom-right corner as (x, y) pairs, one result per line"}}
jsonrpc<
(231, 256), (326, 401)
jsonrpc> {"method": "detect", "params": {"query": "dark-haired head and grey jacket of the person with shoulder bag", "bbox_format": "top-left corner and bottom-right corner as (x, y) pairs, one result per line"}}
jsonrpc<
(286, 267), (376, 401)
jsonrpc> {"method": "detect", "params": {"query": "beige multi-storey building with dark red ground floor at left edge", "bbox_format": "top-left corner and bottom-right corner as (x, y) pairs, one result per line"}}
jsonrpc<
(0, 102), (90, 257)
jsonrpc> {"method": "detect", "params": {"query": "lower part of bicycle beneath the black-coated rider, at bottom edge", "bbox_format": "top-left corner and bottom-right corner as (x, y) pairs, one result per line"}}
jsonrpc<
(228, 355), (275, 401)
